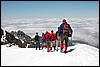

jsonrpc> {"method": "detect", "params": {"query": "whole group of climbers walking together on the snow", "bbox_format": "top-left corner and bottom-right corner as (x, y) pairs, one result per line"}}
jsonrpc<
(35, 19), (73, 53)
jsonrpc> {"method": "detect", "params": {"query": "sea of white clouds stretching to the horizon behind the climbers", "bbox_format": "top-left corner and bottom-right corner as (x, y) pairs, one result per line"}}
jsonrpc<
(1, 17), (99, 48)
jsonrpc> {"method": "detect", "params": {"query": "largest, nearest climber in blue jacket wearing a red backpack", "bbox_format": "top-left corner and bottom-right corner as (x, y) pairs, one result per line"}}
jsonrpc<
(58, 19), (73, 53)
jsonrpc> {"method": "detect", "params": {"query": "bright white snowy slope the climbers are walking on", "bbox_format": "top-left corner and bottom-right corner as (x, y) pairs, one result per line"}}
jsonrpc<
(1, 44), (99, 66)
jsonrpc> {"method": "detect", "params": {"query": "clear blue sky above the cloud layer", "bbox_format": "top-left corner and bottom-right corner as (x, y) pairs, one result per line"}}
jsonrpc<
(1, 1), (99, 19)
